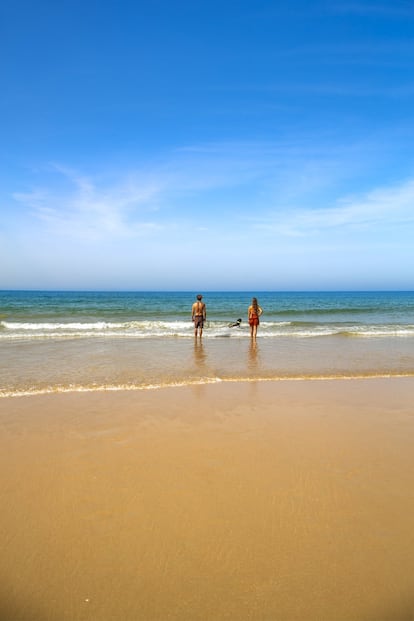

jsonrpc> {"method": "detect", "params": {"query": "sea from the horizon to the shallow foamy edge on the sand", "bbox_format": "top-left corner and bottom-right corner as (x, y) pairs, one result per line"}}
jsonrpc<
(0, 291), (414, 397)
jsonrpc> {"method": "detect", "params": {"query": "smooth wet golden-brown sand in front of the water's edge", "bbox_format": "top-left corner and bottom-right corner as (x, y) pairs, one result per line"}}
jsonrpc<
(0, 378), (414, 621)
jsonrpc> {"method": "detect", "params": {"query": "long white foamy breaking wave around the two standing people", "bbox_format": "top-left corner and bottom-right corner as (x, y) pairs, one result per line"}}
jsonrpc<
(0, 321), (414, 340)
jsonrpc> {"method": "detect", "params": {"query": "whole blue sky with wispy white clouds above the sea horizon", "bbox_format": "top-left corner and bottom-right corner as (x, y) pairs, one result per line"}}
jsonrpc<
(0, 0), (414, 291)
